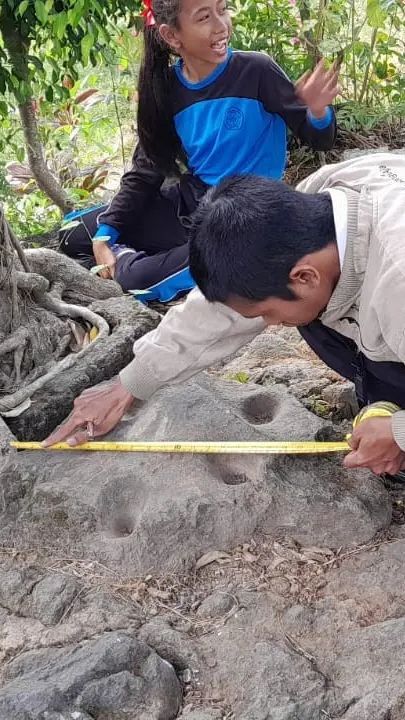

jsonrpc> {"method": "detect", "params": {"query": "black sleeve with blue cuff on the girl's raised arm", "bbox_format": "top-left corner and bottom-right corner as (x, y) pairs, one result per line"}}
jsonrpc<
(260, 56), (336, 150)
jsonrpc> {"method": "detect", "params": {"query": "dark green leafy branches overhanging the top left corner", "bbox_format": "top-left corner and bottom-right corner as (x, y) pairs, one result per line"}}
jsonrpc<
(0, 0), (140, 107)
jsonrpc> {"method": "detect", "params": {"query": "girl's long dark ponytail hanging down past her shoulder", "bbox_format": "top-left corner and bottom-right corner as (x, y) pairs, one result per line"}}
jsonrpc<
(138, 0), (185, 175)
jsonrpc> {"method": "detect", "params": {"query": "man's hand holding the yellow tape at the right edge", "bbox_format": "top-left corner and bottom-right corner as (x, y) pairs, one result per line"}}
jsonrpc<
(343, 417), (405, 475)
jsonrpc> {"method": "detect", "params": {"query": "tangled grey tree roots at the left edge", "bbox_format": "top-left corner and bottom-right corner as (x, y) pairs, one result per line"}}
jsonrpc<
(0, 206), (122, 414)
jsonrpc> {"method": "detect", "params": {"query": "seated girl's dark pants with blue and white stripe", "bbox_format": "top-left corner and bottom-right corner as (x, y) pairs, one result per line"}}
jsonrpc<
(60, 185), (194, 302)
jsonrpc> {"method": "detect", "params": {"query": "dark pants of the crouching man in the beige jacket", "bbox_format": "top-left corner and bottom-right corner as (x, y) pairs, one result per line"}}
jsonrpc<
(298, 320), (405, 408)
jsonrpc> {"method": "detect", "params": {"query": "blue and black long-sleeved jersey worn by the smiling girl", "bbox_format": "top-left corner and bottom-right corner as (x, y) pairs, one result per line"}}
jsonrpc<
(98, 50), (336, 243)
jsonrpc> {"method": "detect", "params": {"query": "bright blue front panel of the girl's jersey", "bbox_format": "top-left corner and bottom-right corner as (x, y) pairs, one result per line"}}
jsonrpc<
(175, 97), (287, 185)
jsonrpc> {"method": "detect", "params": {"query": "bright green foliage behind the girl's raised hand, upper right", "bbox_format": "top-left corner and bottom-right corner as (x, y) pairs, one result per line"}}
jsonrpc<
(232, 0), (405, 106)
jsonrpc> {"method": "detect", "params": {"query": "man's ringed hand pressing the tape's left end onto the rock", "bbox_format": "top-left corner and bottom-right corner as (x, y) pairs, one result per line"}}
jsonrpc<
(43, 378), (135, 447)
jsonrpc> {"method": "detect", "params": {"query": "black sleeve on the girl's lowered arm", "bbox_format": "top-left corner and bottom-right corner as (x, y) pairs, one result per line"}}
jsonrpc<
(98, 144), (165, 240)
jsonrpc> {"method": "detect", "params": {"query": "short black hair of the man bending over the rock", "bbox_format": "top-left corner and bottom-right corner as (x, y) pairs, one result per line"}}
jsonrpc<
(190, 175), (336, 302)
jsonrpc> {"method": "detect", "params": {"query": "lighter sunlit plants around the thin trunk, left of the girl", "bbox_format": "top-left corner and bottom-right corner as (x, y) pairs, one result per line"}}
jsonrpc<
(0, 21), (141, 237)
